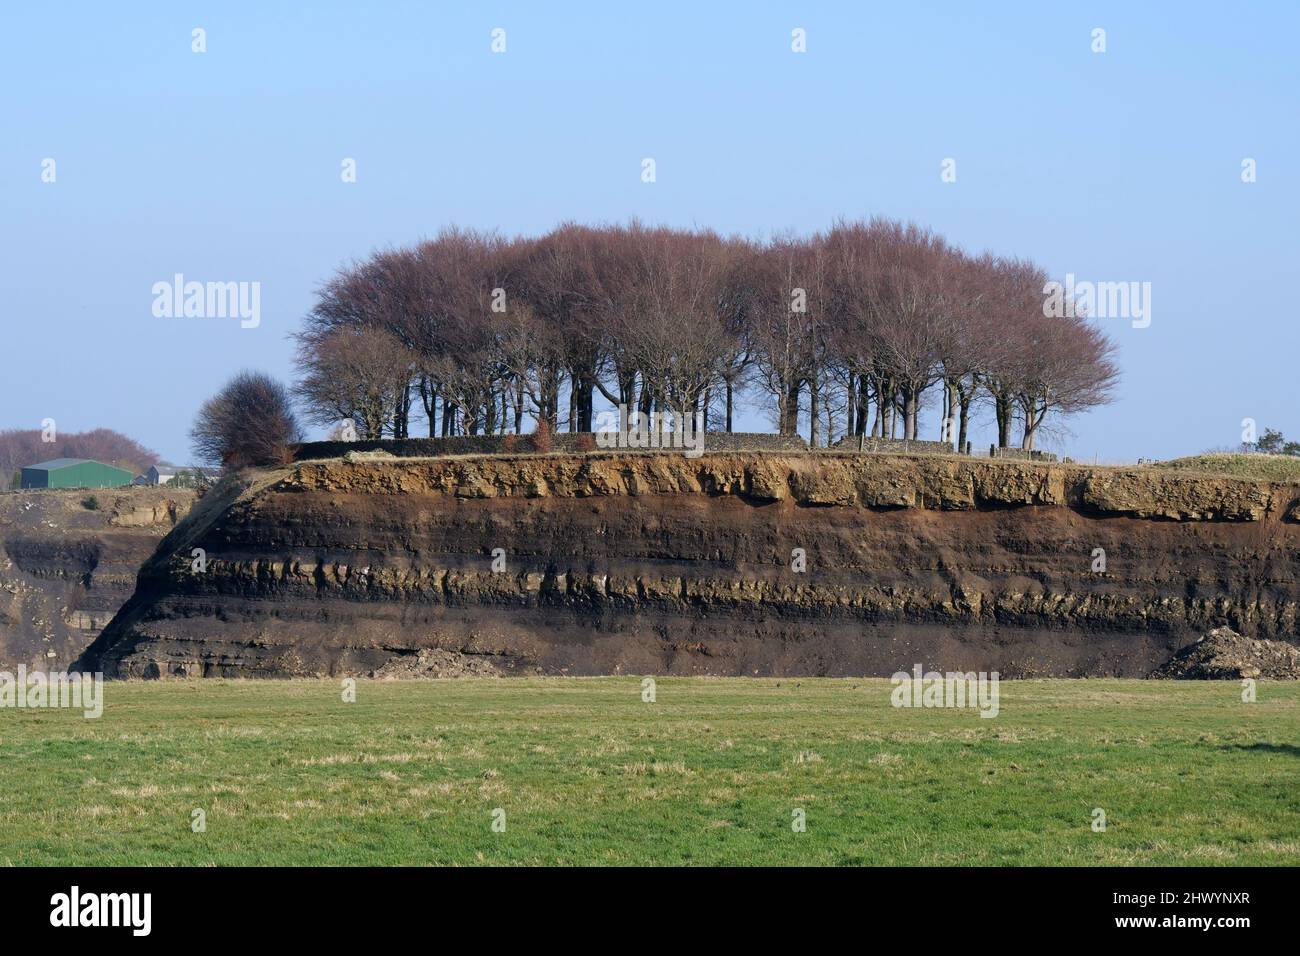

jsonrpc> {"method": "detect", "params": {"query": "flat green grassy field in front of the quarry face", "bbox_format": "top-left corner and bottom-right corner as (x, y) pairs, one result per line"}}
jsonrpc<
(0, 678), (1300, 865)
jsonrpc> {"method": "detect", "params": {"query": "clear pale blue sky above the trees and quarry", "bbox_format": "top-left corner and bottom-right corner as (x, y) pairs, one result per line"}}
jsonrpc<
(0, 0), (1300, 460)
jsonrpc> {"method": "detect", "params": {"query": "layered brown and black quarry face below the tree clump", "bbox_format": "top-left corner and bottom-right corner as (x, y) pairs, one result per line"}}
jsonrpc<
(82, 453), (1300, 676)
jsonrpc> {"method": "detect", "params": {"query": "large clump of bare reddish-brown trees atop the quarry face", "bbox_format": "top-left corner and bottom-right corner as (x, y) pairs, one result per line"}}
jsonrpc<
(295, 220), (1117, 449)
